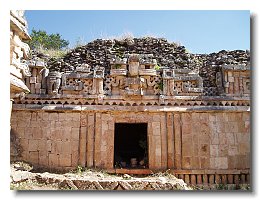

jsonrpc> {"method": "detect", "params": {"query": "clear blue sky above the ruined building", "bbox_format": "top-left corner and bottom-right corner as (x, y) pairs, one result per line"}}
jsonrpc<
(25, 10), (250, 53)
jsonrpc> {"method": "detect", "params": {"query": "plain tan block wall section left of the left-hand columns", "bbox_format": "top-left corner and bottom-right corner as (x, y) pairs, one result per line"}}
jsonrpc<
(11, 112), (80, 169)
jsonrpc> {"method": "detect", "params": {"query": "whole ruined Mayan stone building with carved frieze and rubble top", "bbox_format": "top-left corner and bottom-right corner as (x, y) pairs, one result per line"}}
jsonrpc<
(11, 13), (250, 184)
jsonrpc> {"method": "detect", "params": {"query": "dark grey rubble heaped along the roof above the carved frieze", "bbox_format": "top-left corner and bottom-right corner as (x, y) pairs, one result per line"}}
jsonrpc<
(28, 37), (250, 87)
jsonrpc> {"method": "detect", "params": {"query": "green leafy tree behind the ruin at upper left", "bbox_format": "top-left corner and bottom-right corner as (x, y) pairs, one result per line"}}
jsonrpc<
(28, 29), (69, 50)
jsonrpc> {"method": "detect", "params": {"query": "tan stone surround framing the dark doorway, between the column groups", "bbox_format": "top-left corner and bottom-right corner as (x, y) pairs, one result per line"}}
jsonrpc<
(91, 111), (168, 170)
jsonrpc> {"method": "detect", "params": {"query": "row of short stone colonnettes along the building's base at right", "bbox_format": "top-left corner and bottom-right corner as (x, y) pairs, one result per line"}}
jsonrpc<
(175, 174), (250, 185)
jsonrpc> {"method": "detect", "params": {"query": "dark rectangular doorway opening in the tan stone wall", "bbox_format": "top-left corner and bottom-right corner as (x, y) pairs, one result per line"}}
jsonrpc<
(114, 123), (148, 168)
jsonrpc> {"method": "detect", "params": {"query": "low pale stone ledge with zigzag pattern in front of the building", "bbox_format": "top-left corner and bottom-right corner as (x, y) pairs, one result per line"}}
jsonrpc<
(11, 163), (191, 190)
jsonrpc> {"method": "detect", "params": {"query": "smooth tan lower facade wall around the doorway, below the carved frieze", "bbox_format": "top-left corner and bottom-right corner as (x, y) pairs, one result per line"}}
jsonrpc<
(11, 109), (250, 183)
